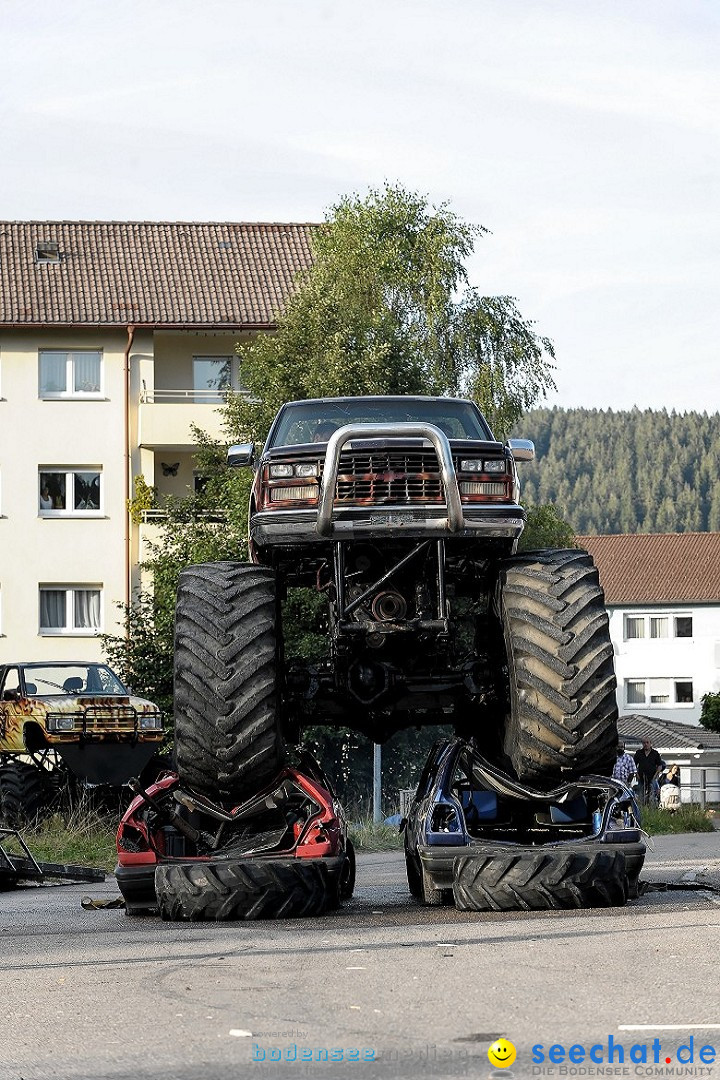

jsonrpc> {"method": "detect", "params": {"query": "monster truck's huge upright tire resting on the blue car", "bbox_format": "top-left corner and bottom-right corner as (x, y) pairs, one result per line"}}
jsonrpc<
(497, 550), (617, 786)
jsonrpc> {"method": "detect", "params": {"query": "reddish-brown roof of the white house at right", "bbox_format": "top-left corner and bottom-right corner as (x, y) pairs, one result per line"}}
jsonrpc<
(578, 532), (720, 605)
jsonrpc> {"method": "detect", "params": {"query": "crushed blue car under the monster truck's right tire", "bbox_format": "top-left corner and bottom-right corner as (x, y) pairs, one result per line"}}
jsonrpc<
(404, 739), (646, 910)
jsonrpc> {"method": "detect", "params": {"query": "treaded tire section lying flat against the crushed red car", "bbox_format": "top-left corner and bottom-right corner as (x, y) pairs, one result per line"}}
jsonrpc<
(155, 859), (337, 922)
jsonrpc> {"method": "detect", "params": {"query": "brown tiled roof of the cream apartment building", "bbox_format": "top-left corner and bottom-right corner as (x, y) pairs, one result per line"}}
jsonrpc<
(0, 221), (317, 328)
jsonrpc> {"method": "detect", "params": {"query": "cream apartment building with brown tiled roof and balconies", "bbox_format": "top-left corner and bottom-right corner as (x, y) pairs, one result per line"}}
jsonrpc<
(0, 221), (313, 662)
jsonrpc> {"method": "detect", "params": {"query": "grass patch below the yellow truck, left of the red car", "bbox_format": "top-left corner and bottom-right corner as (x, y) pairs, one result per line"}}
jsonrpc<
(5, 806), (118, 872)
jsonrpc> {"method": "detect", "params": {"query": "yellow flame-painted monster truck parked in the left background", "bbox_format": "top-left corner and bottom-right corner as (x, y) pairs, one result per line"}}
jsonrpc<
(0, 661), (163, 824)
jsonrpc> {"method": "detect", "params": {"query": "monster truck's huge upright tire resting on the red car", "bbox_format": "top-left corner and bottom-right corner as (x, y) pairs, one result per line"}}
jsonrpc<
(175, 563), (284, 801)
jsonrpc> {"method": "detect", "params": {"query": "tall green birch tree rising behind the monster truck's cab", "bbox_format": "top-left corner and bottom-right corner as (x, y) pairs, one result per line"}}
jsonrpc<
(226, 185), (555, 441)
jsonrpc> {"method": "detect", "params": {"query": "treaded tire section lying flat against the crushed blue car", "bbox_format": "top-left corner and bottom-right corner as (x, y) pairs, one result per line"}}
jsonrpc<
(452, 847), (627, 912)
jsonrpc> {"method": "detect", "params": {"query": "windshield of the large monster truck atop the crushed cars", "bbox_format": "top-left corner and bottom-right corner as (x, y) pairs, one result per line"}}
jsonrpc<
(268, 397), (492, 448)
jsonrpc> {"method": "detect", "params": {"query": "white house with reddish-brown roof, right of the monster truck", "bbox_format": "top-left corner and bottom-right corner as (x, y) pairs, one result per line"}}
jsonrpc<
(578, 532), (720, 725)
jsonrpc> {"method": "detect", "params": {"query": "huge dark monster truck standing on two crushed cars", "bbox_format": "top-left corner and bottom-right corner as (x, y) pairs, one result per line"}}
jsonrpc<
(175, 396), (617, 798)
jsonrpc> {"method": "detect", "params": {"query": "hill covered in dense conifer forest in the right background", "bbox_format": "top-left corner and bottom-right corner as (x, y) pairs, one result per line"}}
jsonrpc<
(513, 408), (720, 535)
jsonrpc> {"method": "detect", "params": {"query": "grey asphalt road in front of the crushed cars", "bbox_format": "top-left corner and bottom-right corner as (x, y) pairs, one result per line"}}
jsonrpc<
(0, 832), (720, 1080)
